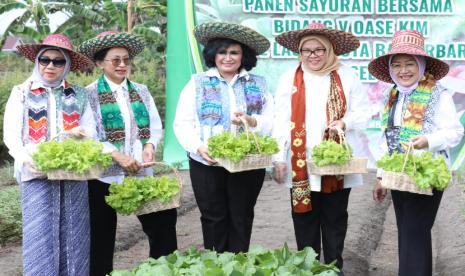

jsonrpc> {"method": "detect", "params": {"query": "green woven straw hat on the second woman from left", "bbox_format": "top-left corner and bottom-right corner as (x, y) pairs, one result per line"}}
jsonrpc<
(79, 31), (145, 60)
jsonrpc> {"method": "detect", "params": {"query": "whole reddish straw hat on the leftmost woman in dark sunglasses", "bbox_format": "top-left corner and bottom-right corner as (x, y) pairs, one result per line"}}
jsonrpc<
(16, 34), (93, 71)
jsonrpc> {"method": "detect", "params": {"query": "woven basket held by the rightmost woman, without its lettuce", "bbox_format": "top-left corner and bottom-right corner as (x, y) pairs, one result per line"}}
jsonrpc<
(381, 171), (433, 195)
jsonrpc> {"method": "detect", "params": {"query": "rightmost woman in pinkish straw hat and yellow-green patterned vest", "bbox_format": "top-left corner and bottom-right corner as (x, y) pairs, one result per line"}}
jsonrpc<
(368, 30), (463, 276)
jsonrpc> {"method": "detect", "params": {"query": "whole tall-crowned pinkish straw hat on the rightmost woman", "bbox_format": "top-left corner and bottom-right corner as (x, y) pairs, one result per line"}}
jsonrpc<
(368, 30), (449, 83)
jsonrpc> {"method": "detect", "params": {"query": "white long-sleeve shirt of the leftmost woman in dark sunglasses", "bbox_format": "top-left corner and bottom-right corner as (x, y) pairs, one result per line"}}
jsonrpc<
(3, 81), (97, 182)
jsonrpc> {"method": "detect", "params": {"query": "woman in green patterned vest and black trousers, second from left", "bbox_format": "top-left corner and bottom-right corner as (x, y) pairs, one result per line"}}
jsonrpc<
(79, 32), (177, 275)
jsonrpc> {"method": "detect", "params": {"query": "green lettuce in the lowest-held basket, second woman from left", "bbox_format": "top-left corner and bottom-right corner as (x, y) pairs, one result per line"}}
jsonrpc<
(105, 176), (180, 215)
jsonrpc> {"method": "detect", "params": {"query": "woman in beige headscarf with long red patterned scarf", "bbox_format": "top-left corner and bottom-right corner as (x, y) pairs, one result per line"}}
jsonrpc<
(273, 23), (368, 268)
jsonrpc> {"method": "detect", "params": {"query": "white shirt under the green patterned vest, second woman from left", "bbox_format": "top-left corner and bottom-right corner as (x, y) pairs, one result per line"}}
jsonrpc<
(88, 77), (162, 184)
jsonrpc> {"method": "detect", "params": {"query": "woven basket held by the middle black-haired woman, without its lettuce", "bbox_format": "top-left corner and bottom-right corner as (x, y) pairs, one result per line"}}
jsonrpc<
(215, 154), (273, 173)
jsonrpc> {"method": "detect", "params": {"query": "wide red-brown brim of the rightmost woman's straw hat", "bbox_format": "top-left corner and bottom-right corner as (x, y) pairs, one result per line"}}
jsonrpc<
(368, 51), (449, 83)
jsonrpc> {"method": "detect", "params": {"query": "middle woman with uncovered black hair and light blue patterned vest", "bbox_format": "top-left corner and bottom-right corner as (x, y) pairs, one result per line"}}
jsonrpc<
(174, 22), (273, 253)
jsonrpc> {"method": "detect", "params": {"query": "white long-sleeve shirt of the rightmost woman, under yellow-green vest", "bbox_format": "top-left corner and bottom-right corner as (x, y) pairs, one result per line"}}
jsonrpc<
(377, 83), (464, 177)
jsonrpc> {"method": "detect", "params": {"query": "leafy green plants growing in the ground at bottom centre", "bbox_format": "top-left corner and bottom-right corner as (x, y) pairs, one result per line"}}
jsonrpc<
(110, 244), (339, 276)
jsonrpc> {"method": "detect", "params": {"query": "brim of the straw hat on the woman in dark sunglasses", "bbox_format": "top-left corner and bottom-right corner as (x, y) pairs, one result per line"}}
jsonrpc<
(16, 44), (93, 71)
